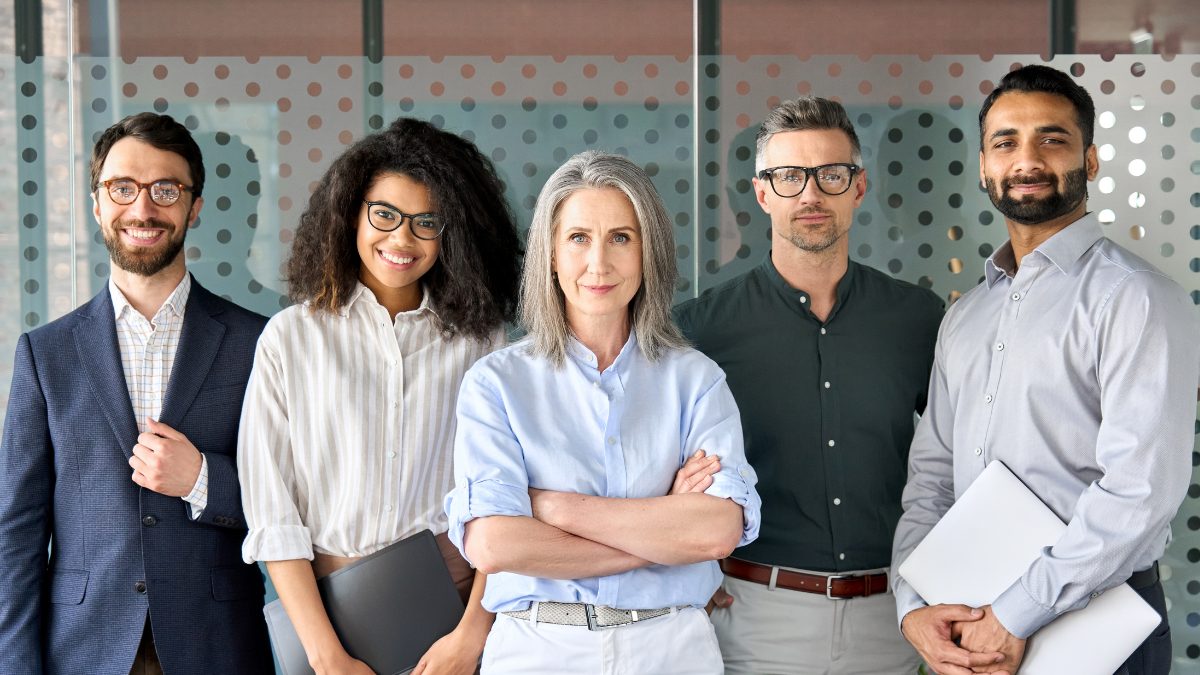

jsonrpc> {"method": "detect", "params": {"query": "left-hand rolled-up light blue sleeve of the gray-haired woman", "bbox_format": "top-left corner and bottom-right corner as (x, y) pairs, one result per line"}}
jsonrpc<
(445, 366), (533, 561)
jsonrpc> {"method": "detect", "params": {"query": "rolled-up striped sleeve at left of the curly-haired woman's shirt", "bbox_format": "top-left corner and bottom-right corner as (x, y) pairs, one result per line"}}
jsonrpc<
(238, 325), (313, 563)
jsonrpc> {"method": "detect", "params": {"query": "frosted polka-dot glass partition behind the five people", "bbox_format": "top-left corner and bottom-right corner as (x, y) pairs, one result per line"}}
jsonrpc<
(0, 61), (1200, 659)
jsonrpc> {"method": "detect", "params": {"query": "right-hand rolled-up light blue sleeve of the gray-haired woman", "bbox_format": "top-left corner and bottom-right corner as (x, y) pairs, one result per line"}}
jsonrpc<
(680, 365), (762, 546)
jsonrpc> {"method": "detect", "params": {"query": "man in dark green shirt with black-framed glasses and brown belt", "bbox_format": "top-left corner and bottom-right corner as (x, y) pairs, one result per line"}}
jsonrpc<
(676, 97), (943, 675)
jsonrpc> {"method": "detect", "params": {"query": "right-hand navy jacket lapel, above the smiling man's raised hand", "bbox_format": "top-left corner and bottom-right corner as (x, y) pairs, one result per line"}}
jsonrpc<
(158, 276), (226, 429)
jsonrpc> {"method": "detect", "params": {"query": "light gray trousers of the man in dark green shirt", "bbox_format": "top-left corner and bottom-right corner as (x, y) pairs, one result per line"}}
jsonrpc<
(710, 566), (920, 675)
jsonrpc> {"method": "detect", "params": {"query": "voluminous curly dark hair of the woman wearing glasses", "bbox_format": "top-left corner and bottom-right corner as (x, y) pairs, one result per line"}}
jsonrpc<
(287, 118), (521, 340)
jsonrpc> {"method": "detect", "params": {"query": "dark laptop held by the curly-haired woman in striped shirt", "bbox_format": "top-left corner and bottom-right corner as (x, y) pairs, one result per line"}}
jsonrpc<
(263, 530), (463, 675)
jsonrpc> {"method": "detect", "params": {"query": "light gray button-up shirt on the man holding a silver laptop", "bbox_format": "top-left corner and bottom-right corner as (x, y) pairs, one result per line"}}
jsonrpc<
(892, 215), (1200, 638)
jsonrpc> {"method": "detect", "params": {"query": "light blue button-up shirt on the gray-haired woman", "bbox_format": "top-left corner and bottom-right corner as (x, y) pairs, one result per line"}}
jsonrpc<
(445, 335), (761, 611)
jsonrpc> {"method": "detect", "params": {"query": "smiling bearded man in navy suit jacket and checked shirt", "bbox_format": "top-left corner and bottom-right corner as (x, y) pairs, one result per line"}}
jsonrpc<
(0, 113), (272, 675)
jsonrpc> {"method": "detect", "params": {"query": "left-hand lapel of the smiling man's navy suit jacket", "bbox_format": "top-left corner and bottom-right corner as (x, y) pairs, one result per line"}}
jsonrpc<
(74, 285), (138, 458)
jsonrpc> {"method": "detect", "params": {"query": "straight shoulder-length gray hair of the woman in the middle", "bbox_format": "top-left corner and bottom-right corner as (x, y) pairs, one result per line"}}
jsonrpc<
(517, 150), (688, 365)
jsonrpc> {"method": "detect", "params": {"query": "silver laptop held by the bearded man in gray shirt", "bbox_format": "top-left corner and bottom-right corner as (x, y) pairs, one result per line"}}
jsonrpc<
(899, 461), (1160, 675)
